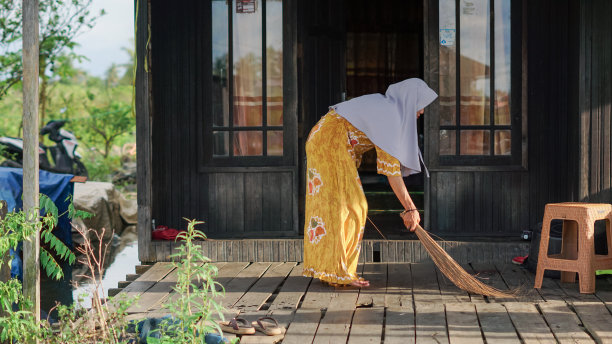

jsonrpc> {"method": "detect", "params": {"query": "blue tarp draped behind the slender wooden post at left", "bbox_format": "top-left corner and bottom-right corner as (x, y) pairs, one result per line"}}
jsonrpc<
(0, 167), (74, 276)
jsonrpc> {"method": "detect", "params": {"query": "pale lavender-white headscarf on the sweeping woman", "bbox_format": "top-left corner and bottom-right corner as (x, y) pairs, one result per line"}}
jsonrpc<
(332, 78), (438, 176)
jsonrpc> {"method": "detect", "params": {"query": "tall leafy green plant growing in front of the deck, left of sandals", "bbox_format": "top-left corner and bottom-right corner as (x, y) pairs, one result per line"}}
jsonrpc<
(147, 220), (237, 344)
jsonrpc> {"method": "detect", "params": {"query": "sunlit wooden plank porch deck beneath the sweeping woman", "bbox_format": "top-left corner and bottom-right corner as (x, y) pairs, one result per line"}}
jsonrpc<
(121, 262), (612, 344)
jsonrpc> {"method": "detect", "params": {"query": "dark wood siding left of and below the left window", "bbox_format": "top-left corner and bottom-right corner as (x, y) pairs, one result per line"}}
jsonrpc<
(150, 0), (297, 238)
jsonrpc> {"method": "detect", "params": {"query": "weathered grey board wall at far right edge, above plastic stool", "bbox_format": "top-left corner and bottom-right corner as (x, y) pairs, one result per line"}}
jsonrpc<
(578, 0), (612, 203)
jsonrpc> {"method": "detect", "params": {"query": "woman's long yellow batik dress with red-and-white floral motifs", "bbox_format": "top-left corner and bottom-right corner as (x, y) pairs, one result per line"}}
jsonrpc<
(303, 110), (401, 284)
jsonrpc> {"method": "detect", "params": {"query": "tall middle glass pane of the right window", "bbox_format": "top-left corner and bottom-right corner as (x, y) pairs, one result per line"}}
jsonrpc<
(459, 0), (491, 125)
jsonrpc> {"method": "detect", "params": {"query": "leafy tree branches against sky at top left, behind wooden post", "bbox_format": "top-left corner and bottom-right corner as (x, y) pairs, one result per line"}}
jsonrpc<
(0, 0), (104, 130)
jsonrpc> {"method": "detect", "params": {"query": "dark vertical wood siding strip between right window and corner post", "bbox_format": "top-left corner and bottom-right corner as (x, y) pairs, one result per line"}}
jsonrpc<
(527, 0), (578, 225)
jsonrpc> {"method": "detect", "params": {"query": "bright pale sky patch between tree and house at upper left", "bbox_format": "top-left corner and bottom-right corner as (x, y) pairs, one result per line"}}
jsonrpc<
(75, 0), (134, 77)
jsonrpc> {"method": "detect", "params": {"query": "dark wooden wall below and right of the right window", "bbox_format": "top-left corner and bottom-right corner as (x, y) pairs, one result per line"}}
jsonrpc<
(425, 0), (578, 237)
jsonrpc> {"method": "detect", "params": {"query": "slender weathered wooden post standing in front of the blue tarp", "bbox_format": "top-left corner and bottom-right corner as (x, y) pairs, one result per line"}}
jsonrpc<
(23, 0), (40, 326)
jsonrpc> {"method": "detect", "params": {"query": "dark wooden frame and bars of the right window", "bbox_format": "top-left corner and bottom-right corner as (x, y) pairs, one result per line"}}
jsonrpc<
(425, 0), (526, 171)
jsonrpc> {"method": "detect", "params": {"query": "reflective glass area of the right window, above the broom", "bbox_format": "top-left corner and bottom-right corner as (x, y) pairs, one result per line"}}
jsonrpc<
(439, 0), (512, 160)
